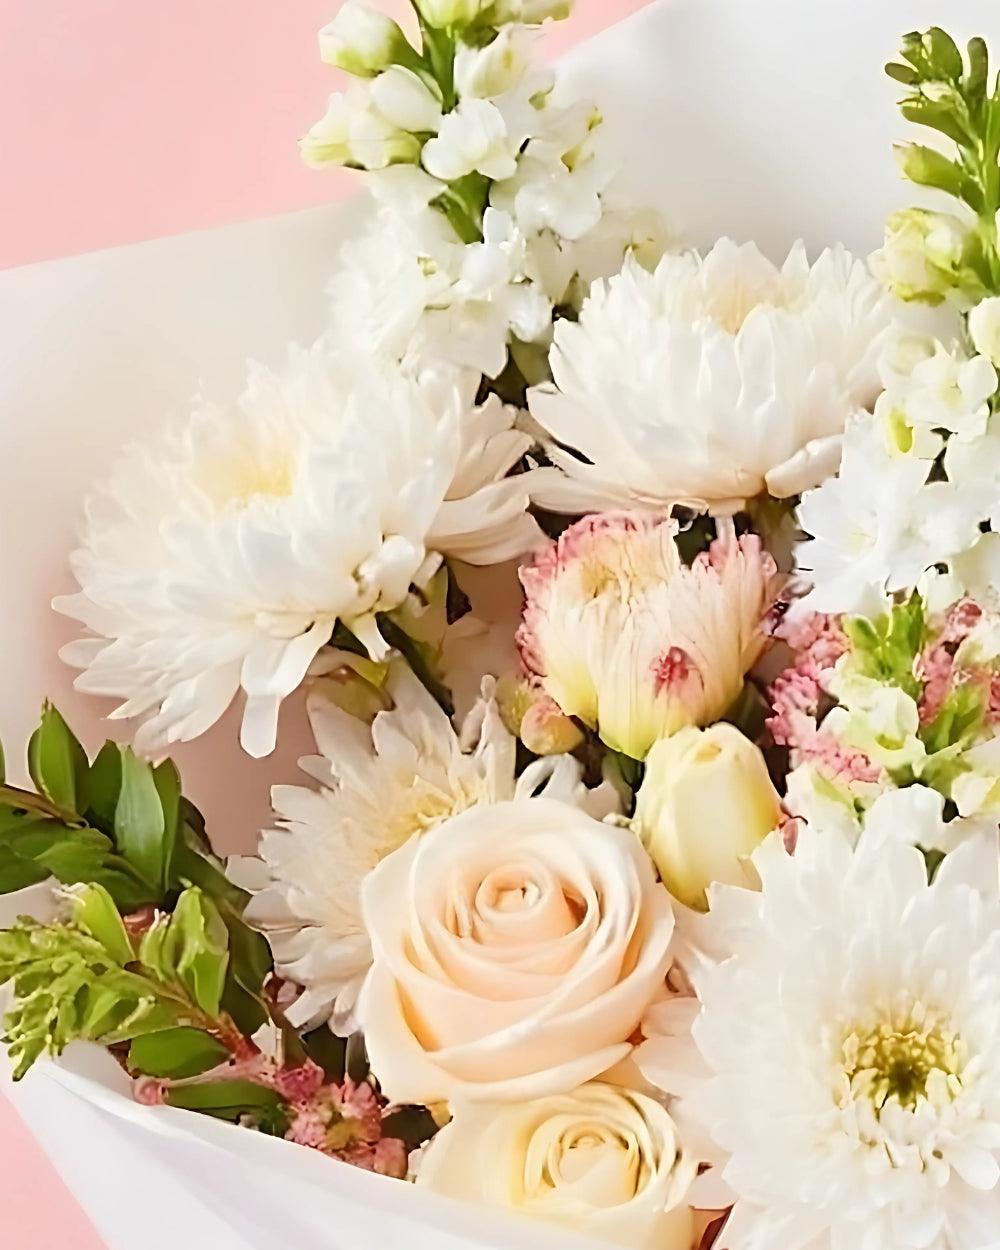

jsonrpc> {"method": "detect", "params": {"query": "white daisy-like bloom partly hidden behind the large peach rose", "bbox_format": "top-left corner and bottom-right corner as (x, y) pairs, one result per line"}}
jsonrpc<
(230, 661), (618, 1031)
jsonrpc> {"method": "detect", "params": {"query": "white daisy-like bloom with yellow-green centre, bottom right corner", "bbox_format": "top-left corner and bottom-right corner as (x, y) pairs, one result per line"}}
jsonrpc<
(638, 788), (1000, 1250)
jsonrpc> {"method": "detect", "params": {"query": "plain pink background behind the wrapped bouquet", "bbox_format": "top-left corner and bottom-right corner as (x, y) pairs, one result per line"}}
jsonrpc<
(0, 0), (648, 1250)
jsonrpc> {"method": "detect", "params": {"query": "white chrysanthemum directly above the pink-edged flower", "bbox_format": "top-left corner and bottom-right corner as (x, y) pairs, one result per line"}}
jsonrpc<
(531, 239), (895, 514)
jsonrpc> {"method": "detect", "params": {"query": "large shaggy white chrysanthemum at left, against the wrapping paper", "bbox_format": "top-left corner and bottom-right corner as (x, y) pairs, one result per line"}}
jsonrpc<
(56, 351), (538, 755)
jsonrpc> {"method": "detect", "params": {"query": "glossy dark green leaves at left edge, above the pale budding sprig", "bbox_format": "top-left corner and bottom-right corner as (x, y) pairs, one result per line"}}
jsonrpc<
(0, 705), (273, 1075)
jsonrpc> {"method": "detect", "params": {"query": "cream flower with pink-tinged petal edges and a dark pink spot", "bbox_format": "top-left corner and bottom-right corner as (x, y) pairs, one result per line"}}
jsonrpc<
(518, 513), (778, 759)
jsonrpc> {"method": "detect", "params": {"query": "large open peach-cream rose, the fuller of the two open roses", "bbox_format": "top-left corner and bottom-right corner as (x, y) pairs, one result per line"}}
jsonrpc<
(359, 799), (674, 1104)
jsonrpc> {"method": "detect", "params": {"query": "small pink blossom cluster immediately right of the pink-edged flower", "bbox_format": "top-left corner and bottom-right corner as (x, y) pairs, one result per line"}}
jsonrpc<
(768, 613), (879, 784)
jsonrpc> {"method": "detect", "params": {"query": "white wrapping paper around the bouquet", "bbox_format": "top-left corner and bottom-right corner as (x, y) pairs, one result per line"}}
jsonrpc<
(0, 0), (1000, 1250)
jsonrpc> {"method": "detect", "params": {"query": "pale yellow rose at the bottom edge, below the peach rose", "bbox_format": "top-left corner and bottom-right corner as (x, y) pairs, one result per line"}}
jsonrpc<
(416, 1081), (696, 1250)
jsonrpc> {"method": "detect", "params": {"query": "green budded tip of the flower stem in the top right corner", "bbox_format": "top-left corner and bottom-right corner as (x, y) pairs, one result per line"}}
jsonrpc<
(886, 26), (1000, 295)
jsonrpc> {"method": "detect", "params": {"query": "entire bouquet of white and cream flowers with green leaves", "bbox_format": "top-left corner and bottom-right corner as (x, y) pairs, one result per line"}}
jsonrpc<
(0, 0), (1000, 1250)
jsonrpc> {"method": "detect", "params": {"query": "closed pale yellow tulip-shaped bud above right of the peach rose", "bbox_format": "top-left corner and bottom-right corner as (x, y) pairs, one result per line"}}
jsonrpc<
(633, 724), (781, 911)
